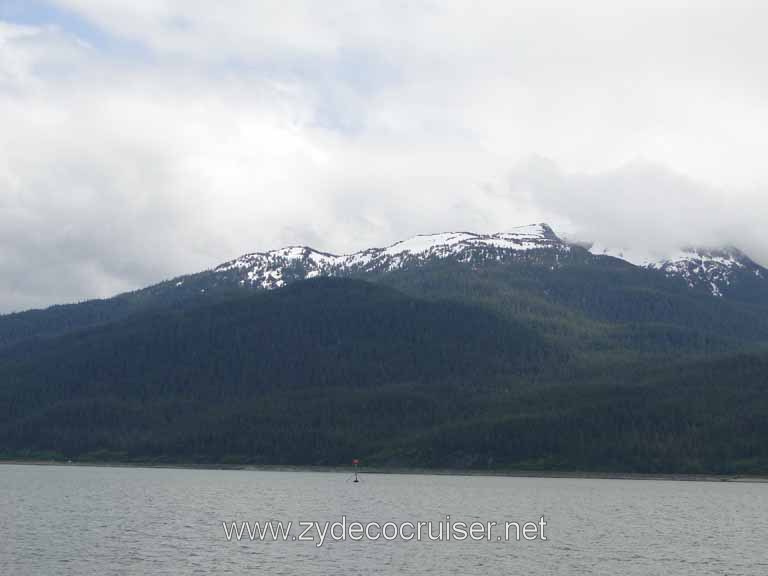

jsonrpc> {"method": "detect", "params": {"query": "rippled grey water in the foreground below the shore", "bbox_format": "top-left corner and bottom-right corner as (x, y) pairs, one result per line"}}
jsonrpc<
(0, 465), (768, 576)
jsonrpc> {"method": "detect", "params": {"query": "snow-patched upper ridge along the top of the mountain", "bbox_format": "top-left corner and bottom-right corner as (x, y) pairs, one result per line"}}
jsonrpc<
(170, 224), (768, 302)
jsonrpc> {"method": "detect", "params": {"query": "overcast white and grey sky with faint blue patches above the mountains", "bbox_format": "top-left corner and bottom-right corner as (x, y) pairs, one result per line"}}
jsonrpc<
(0, 0), (768, 313)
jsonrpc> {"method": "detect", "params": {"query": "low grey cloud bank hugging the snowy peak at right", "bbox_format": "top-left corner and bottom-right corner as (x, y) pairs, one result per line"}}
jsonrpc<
(510, 158), (768, 263)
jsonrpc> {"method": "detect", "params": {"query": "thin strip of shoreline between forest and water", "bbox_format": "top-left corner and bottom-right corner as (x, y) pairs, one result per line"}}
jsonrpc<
(0, 459), (768, 483)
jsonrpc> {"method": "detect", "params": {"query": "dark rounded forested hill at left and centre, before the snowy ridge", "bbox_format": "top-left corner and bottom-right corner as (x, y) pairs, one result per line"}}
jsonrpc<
(0, 279), (564, 463)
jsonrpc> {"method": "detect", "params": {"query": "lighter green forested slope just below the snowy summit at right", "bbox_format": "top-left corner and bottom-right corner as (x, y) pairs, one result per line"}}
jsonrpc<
(379, 255), (768, 355)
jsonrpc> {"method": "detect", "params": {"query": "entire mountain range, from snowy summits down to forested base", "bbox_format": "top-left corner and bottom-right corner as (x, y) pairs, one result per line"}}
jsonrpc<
(0, 225), (768, 473)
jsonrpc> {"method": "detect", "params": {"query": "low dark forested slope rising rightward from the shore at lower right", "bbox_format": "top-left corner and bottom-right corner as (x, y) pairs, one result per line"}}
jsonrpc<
(374, 352), (768, 474)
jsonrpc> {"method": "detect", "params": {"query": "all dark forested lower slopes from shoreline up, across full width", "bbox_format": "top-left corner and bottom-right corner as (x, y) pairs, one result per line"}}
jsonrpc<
(0, 279), (768, 473)
